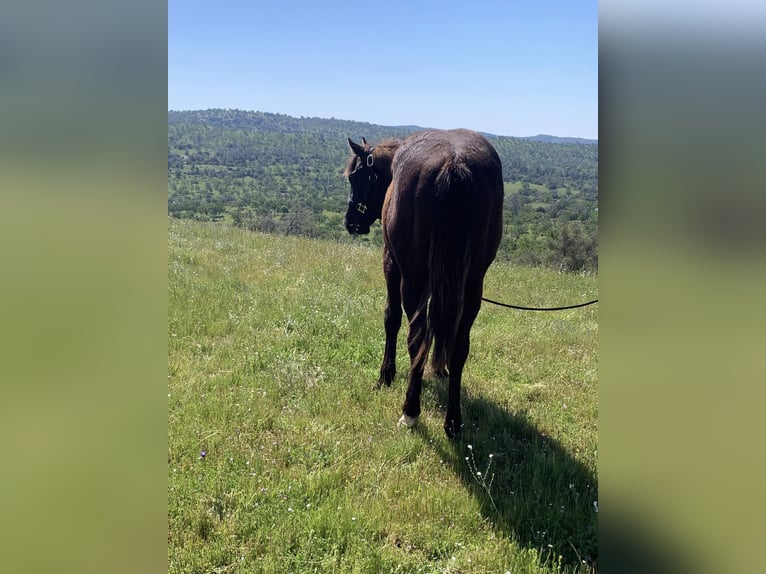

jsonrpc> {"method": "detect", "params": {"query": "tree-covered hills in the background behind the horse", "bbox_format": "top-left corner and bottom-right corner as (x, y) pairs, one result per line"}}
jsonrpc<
(168, 109), (598, 269)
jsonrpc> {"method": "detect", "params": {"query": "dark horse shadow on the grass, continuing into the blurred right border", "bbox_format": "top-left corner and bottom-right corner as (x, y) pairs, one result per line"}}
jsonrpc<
(415, 379), (704, 573)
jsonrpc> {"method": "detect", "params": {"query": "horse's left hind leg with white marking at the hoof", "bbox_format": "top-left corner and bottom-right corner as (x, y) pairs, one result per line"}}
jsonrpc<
(399, 287), (431, 427)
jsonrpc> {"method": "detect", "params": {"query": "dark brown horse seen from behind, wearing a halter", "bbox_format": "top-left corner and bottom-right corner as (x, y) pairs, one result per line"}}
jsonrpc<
(344, 129), (504, 439)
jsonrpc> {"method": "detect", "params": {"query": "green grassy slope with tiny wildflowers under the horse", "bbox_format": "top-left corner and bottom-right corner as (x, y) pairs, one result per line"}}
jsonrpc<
(168, 219), (598, 573)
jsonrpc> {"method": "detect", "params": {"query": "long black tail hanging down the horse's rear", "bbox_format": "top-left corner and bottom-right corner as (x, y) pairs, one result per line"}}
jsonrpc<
(427, 163), (473, 370)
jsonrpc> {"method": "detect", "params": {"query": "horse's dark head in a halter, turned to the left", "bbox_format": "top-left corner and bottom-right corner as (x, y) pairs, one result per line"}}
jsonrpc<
(343, 138), (391, 235)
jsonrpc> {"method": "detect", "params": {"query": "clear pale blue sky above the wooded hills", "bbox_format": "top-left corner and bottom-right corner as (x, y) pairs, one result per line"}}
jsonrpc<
(168, 0), (598, 139)
